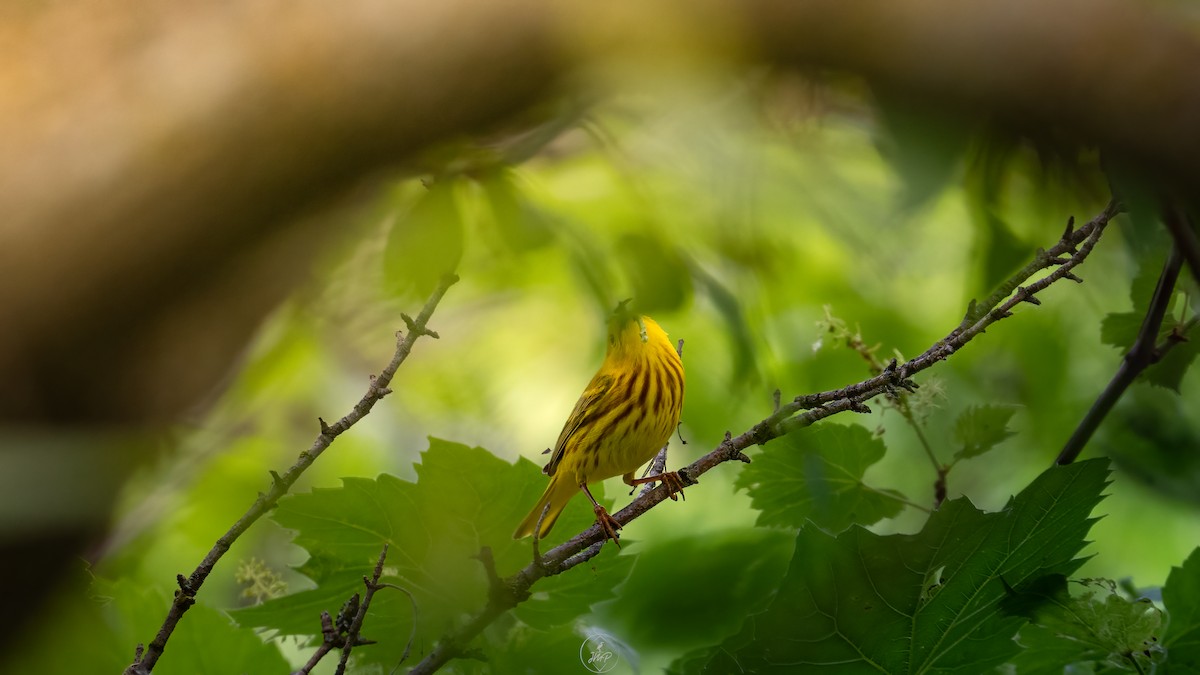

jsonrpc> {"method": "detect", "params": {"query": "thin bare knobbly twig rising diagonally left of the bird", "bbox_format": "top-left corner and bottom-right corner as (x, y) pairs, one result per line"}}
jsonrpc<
(125, 275), (458, 675)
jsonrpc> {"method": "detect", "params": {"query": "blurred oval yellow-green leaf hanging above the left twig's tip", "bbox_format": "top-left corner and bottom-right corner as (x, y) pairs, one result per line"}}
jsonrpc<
(383, 179), (463, 298)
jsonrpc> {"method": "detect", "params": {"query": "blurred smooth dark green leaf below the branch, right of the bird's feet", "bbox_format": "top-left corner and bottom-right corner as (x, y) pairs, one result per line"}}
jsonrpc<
(595, 528), (796, 652)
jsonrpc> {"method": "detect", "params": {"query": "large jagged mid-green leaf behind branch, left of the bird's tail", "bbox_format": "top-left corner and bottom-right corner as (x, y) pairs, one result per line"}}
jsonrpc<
(234, 438), (634, 664)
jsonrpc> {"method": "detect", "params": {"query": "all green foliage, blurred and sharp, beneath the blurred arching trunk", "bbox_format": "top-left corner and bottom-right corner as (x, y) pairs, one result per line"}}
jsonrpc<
(14, 72), (1200, 675)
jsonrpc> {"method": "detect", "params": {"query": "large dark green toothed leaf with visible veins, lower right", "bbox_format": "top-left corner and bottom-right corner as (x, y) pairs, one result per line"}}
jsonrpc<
(674, 460), (1108, 675)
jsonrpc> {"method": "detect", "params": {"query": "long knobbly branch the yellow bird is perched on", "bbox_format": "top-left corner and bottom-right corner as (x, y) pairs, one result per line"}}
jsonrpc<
(409, 202), (1121, 675)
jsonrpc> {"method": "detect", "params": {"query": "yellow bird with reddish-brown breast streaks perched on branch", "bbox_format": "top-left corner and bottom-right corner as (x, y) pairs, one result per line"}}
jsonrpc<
(512, 300), (683, 545)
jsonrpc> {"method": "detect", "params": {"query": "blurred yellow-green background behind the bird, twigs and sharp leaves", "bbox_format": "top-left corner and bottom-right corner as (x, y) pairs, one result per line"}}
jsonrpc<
(12, 70), (1200, 673)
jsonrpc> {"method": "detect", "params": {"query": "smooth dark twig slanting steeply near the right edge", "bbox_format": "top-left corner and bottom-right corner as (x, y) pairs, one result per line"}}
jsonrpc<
(1055, 239), (1183, 465)
